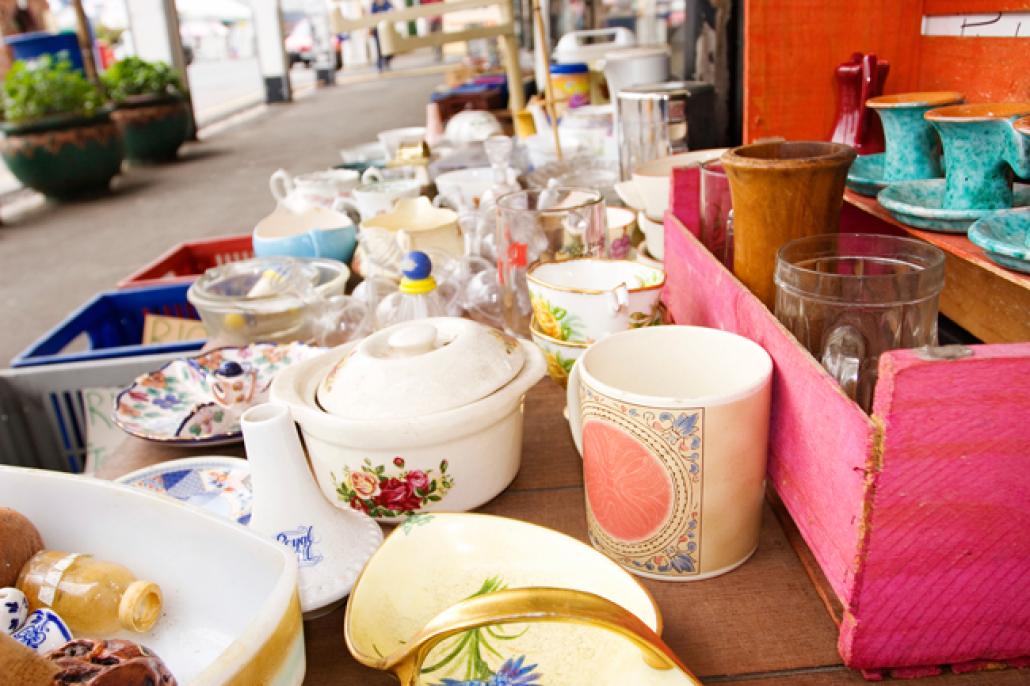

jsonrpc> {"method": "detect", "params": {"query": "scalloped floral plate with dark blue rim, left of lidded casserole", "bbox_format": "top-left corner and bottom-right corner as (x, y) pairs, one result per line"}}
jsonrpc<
(112, 343), (322, 445)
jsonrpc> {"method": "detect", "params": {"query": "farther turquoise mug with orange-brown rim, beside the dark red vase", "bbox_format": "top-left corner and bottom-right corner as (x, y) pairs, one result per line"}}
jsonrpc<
(866, 91), (962, 182)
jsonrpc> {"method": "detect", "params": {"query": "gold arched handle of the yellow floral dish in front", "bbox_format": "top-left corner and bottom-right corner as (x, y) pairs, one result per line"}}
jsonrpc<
(374, 587), (700, 686)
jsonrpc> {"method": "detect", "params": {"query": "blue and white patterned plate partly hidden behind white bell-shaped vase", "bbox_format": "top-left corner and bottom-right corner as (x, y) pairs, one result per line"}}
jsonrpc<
(115, 455), (253, 525)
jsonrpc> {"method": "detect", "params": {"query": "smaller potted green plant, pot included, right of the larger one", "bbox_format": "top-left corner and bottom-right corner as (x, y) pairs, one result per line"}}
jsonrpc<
(102, 57), (192, 163)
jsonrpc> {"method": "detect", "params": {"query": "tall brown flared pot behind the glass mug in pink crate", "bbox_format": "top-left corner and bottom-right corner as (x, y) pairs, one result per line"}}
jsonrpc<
(722, 141), (855, 309)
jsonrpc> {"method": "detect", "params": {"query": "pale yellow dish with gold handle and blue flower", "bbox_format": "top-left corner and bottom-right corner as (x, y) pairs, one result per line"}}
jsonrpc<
(344, 514), (700, 686)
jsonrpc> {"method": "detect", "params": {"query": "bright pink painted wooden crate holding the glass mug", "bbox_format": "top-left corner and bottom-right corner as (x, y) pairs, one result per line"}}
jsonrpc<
(664, 207), (1030, 678)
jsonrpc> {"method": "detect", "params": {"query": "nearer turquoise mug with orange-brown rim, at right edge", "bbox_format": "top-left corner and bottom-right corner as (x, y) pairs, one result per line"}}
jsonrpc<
(926, 102), (1030, 209)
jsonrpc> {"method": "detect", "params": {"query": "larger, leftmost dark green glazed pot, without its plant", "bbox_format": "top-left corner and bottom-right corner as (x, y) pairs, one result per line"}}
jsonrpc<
(0, 111), (123, 200)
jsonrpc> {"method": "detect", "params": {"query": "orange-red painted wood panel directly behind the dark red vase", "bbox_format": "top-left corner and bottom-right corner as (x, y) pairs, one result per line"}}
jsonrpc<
(744, 0), (922, 142)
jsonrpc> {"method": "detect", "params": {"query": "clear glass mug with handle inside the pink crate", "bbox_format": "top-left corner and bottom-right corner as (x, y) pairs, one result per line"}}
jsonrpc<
(775, 234), (945, 412)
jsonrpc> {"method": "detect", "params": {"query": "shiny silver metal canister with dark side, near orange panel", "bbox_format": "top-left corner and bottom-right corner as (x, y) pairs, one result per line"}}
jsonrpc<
(617, 81), (715, 179)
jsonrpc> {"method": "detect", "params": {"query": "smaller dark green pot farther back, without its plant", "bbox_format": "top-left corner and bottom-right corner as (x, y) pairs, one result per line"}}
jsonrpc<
(111, 97), (190, 164)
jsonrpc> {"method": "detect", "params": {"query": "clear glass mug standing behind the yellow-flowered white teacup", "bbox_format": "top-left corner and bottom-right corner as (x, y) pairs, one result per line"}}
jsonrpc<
(494, 186), (608, 338)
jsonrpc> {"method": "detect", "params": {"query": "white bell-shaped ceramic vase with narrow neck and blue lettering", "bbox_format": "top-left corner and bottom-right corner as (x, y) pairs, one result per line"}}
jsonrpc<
(240, 403), (383, 619)
